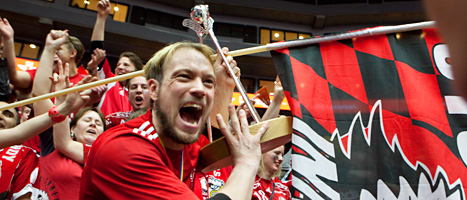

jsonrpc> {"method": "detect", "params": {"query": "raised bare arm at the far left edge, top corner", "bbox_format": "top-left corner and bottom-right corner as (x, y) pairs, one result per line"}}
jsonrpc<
(0, 18), (31, 89)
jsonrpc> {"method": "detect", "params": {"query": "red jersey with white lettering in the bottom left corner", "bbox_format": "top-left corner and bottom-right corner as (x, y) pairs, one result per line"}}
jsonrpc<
(0, 145), (40, 199)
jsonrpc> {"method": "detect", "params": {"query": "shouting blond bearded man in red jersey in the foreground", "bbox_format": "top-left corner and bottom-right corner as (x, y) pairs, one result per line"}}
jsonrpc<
(80, 42), (267, 199)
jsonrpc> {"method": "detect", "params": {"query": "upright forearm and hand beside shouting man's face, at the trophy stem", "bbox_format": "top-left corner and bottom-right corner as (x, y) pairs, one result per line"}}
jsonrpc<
(210, 47), (240, 128)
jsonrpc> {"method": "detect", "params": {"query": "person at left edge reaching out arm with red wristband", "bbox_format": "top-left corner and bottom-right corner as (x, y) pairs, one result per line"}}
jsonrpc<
(0, 70), (98, 199)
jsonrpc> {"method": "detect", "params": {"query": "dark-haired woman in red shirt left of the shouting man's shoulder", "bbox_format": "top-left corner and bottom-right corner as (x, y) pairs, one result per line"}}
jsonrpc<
(39, 107), (105, 200)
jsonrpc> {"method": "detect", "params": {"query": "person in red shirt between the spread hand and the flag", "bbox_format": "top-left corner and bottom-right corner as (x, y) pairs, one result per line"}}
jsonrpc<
(251, 145), (291, 200)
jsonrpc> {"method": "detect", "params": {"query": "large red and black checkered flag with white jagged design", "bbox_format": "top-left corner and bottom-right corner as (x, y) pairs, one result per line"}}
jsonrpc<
(271, 29), (467, 199)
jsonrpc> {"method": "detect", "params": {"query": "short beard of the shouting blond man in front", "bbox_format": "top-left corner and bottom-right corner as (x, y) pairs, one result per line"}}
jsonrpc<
(154, 98), (206, 144)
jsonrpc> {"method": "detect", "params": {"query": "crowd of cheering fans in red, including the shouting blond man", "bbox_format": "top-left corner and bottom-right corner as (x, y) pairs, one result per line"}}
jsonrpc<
(0, 0), (290, 199)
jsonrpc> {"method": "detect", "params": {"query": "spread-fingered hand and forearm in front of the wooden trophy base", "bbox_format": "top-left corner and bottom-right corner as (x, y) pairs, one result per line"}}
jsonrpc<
(217, 104), (268, 199)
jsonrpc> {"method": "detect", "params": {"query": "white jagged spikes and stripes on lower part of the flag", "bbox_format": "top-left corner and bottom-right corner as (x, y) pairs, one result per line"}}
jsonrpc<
(292, 100), (464, 200)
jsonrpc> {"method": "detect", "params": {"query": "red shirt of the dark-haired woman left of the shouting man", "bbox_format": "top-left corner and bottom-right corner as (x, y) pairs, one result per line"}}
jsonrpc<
(39, 144), (90, 200)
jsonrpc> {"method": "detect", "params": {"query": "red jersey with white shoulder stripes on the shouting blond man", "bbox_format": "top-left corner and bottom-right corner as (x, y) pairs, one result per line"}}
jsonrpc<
(80, 110), (208, 200)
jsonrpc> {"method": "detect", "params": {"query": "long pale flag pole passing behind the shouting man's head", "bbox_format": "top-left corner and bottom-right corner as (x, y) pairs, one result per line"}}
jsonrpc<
(0, 21), (435, 111)
